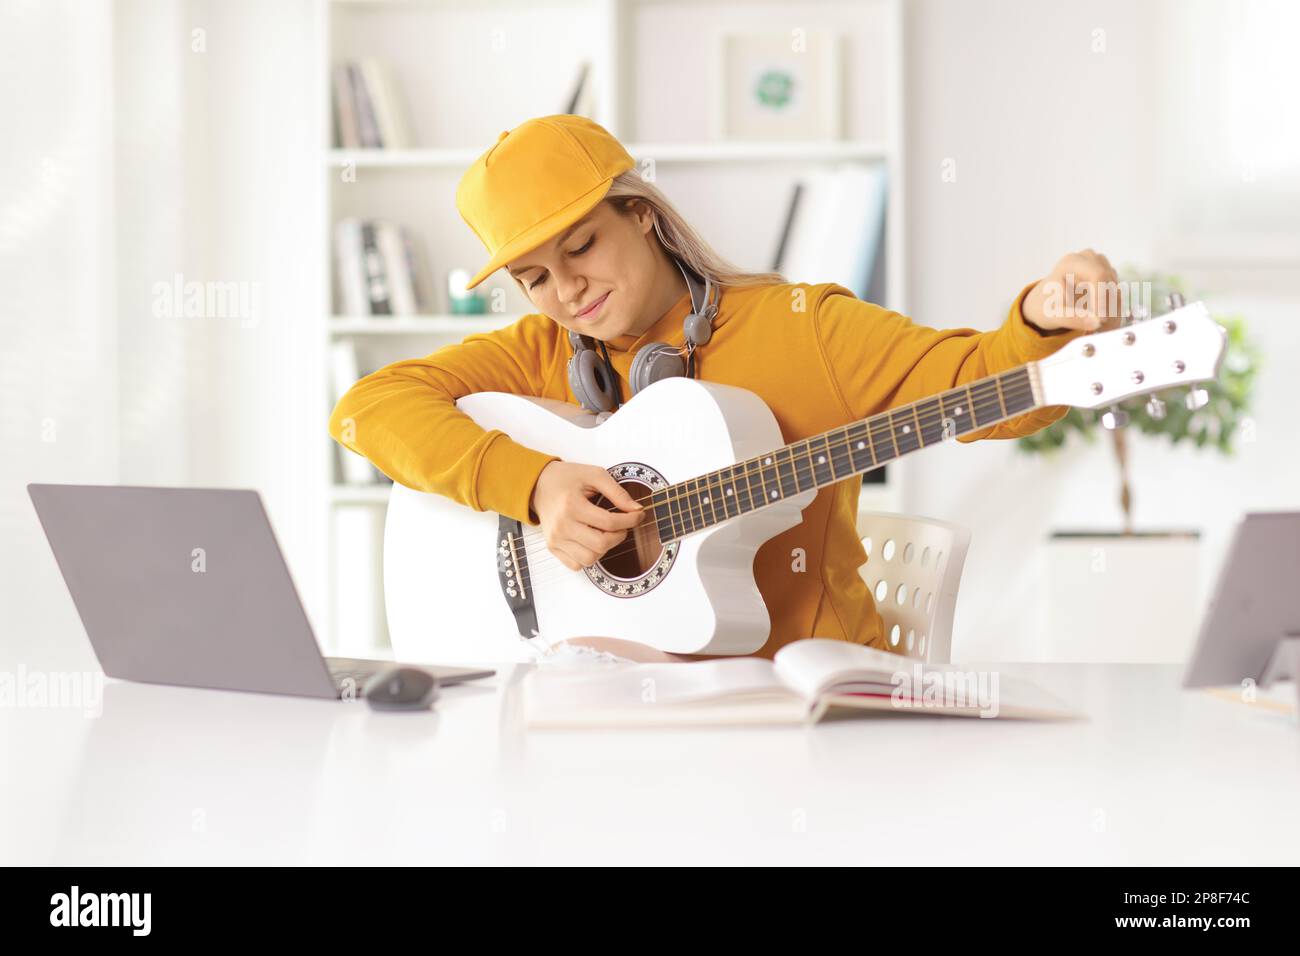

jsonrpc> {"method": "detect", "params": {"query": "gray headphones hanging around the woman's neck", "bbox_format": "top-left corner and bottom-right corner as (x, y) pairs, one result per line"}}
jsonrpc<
(568, 259), (718, 414)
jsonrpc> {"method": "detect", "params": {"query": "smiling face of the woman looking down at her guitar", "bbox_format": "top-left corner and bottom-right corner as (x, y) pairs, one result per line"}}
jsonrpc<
(507, 200), (658, 341)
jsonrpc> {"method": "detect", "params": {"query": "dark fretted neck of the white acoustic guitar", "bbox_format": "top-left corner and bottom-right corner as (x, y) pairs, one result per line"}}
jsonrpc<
(651, 363), (1040, 542)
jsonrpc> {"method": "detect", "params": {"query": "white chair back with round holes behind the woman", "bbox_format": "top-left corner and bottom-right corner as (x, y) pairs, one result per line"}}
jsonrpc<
(858, 511), (971, 663)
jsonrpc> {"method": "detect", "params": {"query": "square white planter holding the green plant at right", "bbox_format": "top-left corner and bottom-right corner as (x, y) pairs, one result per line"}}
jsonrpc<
(1028, 531), (1200, 663)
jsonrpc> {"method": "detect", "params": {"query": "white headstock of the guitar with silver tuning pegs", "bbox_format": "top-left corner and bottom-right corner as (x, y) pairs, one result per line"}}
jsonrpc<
(1036, 302), (1227, 408)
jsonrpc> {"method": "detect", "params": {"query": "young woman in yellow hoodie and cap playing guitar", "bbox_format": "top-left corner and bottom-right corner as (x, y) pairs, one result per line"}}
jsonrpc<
(330, 116), (1117, 657)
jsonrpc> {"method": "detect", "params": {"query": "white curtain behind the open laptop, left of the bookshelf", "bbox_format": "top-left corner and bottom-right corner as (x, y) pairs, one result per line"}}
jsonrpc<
(0, 0), (321, 669)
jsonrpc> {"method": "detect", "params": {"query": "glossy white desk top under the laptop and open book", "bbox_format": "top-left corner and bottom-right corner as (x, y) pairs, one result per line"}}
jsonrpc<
(0, 662), (1300, 865)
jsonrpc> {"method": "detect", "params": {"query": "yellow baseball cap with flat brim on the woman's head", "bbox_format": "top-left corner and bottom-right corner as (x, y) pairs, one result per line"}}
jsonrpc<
(456, 113), (636, 289)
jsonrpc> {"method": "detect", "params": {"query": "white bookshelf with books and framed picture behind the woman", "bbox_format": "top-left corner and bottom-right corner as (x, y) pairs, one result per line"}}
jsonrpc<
(309, 0), (906, 656)
